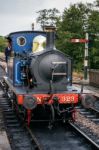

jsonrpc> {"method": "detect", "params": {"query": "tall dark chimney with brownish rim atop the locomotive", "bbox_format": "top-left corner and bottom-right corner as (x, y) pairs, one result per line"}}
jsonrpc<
(44, 26), (56, 50)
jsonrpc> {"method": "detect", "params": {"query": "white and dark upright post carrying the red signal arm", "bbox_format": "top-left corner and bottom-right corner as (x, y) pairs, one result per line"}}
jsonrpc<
(84, 33), (89, 80)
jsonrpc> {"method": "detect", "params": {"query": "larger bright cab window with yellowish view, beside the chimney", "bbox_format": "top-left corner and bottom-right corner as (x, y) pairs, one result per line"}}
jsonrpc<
(32, 35), (46, 53)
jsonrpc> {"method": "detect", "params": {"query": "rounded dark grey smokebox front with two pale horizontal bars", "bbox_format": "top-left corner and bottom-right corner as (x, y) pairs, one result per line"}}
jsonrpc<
(30, 49), (71, 91)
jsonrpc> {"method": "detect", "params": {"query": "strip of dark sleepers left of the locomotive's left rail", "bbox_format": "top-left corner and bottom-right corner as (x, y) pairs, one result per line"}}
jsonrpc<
(0, 93), (38, 150)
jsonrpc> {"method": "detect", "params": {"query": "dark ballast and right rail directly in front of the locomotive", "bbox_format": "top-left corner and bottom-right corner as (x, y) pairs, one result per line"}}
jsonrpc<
(29, 123), (99, 150)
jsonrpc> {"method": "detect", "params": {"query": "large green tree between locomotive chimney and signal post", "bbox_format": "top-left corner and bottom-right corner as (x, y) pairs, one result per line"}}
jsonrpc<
(56, 3), (88, 70)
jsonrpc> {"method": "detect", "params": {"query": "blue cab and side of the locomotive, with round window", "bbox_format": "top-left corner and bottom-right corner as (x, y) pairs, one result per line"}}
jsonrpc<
(8, 31), (46, 86)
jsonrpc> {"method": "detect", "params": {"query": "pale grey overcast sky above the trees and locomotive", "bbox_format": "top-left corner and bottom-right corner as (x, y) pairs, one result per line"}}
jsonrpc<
(0, 0), (94, 35)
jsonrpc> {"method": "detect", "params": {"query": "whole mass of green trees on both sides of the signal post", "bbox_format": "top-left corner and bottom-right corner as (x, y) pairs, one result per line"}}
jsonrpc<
(56, 0), (99, 70)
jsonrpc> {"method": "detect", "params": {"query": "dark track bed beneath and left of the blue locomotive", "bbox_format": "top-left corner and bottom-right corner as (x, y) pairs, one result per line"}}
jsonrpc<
(0, 85), (96, 150)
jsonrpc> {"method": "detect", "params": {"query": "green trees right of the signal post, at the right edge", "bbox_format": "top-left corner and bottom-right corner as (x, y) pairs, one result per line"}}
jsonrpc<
(88, 0), (99, 69)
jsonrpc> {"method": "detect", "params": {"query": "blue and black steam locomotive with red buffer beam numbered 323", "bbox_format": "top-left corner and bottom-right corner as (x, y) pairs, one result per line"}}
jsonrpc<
(4, 26), (79, 125)
